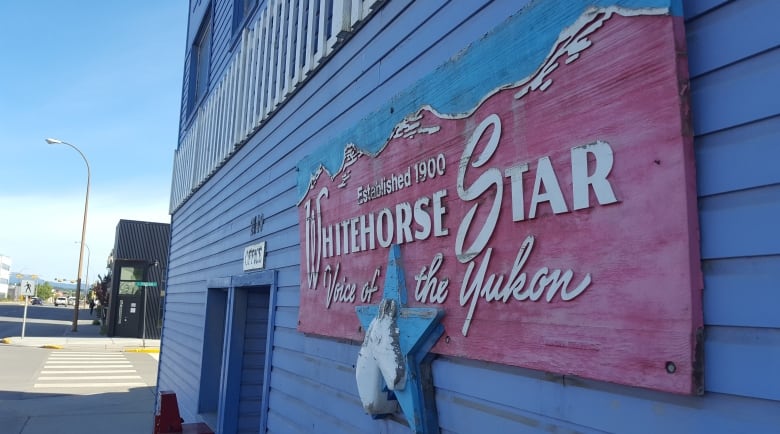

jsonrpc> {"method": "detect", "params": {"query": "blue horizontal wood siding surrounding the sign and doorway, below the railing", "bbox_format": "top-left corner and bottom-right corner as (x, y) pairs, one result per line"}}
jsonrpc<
(159, 0), (780, 433)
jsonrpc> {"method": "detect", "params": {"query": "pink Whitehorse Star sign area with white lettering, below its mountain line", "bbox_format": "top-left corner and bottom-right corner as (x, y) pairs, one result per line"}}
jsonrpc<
(299, 2), (702, 393)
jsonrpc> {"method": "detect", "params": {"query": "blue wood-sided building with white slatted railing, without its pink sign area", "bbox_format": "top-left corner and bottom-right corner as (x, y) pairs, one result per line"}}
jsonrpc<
(158, 0), (780, 434)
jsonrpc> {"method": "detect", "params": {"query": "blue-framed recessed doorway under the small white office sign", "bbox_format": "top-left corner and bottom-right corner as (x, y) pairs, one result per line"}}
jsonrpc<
(199, 271), (276, 433)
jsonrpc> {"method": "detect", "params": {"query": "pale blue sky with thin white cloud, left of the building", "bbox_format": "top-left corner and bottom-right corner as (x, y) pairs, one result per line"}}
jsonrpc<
(0, 0), (188, 282)
